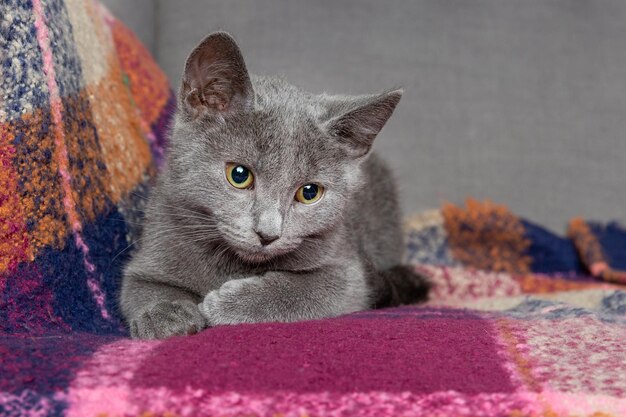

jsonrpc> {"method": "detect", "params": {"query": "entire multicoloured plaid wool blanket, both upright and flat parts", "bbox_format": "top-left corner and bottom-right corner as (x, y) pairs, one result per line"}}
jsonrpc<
(0, 0), (626, 417)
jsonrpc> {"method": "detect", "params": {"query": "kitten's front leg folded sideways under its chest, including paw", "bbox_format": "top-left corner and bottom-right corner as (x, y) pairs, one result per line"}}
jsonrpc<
(199, 266), (369, 326)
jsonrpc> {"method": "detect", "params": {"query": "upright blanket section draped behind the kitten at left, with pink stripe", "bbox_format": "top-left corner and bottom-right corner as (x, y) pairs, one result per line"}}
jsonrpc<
(0, 0), (174, 334)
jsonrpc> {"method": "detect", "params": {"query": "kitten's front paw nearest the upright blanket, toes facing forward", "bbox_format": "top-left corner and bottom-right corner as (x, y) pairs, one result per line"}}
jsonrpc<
(130, 301), (206, 339)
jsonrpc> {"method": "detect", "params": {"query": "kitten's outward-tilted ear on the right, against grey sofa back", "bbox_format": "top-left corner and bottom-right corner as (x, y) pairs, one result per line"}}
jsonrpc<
(325, 90), (403, 158)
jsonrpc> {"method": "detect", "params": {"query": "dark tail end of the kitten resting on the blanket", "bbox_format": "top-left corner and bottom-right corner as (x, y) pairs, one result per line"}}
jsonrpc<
(372, 265), (432, 308)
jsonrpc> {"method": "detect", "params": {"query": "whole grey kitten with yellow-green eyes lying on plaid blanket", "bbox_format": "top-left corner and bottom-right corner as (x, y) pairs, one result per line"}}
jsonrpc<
(121, 33), (428, 338)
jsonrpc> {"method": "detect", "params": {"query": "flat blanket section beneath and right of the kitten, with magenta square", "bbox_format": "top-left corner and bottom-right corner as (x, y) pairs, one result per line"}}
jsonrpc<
(0, 201), (626, 417)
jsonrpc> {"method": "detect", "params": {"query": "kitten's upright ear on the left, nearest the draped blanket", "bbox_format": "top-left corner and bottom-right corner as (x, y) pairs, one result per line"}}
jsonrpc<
(179, 32), (254, 119)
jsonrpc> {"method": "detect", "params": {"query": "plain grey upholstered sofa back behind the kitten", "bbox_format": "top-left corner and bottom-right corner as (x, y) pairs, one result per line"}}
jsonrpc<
(101, 0), (626, 231)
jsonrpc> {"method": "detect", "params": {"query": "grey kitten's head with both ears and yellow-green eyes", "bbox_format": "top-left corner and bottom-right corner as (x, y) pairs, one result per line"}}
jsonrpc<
(166, 33), (402, 262)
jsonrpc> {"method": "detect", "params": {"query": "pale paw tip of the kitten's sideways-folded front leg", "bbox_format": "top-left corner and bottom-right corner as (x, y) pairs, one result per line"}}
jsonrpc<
(198, 277), (259, 326)
